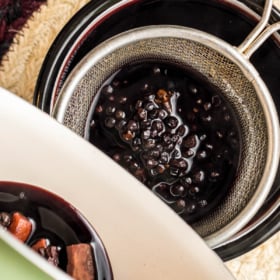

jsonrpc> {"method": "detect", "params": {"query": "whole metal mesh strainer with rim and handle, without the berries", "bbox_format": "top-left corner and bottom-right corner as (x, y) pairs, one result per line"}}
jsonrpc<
(53, 1), (280, 248)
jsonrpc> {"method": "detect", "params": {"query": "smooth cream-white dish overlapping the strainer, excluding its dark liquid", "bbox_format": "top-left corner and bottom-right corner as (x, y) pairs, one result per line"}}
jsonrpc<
(0, 88), (233, 280)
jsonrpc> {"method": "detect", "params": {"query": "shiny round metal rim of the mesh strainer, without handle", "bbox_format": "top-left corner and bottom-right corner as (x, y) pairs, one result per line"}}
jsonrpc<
(52, 25), (280, 248)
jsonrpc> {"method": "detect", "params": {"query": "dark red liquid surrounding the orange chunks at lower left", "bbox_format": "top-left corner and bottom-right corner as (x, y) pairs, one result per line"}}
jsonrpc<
(0, 182), (112, 279)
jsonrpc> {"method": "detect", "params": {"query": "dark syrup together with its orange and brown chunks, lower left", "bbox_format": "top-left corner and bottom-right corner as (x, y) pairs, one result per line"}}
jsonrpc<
(0, 182), (112, 280)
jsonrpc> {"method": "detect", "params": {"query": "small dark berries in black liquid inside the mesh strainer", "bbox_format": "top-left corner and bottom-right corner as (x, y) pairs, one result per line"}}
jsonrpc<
(86, 62), (240, 224)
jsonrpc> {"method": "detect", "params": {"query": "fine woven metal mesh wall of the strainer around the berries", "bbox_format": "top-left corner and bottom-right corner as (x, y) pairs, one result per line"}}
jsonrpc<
(55, 25), (276, 244)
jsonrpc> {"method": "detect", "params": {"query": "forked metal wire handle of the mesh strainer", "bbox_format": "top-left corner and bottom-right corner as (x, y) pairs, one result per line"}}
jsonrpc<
(237, 0), (280, 59)
